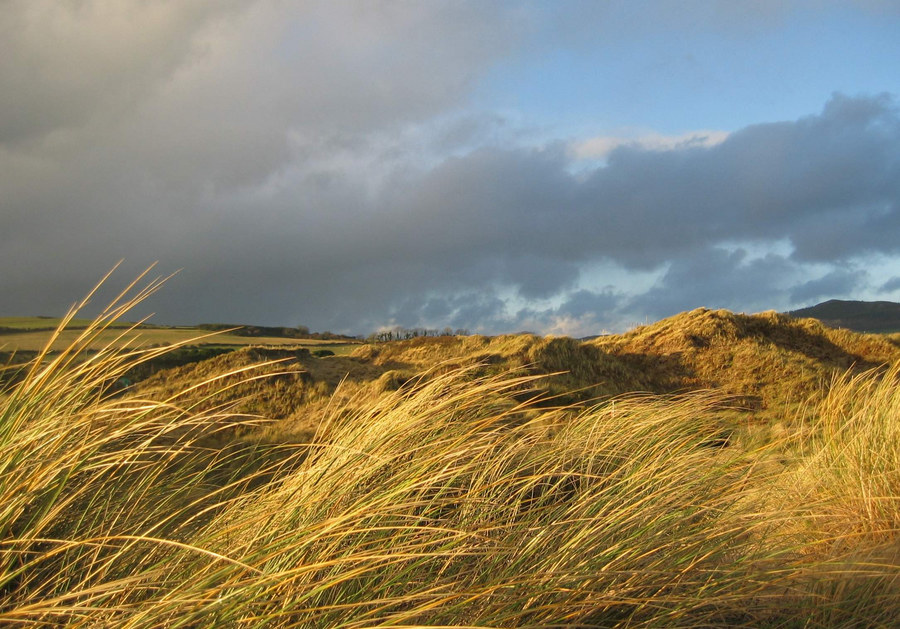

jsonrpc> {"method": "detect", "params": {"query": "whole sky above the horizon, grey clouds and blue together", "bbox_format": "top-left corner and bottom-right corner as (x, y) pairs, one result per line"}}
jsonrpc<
(0, 0), (900, 336)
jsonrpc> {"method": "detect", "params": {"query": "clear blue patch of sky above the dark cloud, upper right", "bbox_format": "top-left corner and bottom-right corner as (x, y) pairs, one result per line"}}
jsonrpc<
(471, 6), (900, 137)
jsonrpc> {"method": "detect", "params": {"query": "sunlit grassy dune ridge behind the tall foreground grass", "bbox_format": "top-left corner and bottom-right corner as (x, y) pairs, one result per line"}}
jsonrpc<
(128, 309), (900, 441)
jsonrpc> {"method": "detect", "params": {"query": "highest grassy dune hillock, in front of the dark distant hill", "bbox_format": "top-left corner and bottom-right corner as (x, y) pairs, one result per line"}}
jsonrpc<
(592, 308), (900, 418)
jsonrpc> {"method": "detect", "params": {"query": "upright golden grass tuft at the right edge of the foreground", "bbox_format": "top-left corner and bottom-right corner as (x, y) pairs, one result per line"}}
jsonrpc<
(790, 365), (900, 626)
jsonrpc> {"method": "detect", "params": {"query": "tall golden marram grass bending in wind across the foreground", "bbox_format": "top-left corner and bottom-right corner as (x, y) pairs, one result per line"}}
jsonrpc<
(0, 274), (900, 627)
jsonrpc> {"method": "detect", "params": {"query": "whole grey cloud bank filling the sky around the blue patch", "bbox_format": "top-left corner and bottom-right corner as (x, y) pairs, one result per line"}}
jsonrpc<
(0, 2), (900, 334)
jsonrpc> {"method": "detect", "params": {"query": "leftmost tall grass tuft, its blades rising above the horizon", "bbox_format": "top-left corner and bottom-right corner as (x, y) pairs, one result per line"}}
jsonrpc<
(0, 273), (292, 624)
